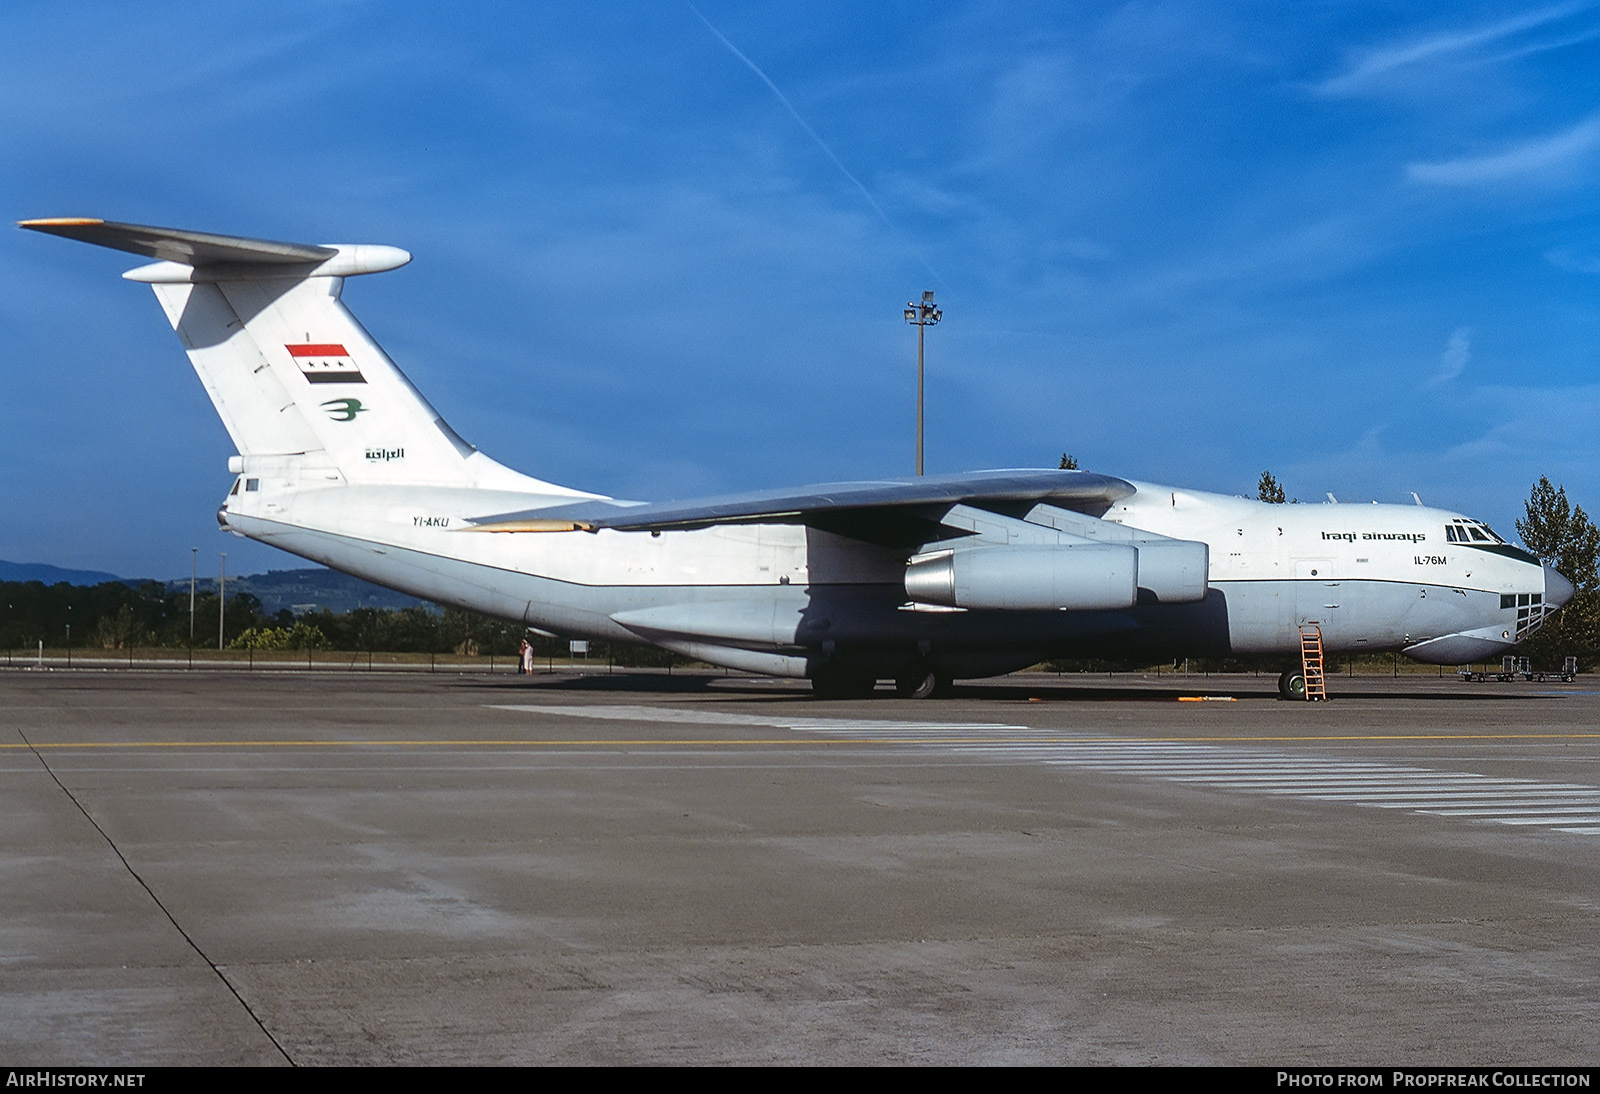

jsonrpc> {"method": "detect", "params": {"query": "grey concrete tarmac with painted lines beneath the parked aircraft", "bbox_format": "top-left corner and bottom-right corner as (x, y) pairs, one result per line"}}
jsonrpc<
(0, 670), (1600, 1067)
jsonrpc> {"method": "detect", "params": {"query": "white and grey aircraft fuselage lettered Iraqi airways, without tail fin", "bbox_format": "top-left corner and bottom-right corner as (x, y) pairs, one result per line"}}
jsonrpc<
(212, 478), (1570, 677)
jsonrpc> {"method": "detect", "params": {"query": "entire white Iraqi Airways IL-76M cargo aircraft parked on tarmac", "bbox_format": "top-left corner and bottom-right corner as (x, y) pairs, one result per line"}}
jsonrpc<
(22, 218), (1573, 697)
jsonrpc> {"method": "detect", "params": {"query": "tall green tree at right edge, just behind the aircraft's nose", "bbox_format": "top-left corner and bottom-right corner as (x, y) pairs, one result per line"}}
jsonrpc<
(1517, 475), (1600, 669)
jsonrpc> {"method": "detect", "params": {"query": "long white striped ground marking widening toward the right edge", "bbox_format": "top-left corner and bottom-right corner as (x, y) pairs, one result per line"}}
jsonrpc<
(501, 705), (1600, 835)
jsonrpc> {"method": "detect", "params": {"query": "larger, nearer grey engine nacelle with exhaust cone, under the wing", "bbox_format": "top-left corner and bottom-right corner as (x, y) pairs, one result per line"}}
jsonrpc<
(906, 542), (1139, 611)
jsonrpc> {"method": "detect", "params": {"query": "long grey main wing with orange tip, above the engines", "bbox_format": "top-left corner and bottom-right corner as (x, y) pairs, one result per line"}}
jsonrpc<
(472, 470), (1134, 541)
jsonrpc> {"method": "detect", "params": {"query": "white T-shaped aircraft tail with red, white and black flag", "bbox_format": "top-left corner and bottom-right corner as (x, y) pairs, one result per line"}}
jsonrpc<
(21, 218), (586, 496)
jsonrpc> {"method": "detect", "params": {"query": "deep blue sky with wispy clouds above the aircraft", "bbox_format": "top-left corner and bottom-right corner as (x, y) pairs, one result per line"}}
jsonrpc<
(0, 0), (1600, 576)
